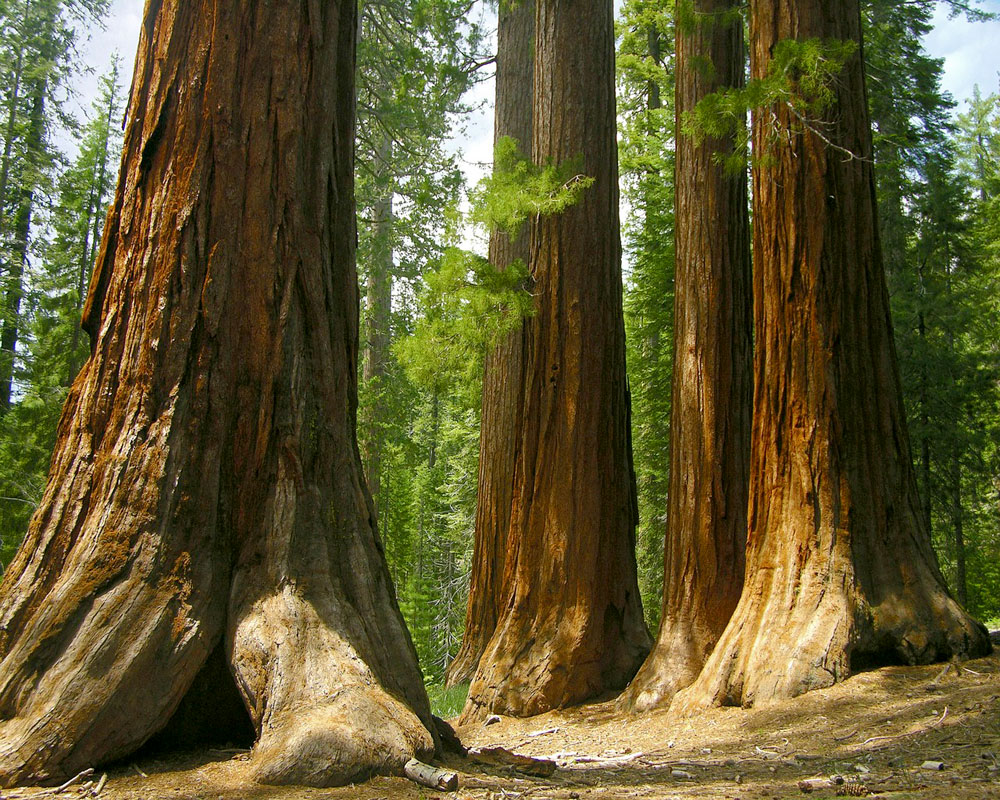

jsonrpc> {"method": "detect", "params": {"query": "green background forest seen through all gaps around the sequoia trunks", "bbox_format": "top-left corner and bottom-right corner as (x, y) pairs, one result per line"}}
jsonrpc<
(0, 0), (1000, 683)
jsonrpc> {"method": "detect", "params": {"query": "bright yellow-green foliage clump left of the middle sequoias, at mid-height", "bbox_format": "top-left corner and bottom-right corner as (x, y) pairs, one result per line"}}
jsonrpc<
(396, 248), (532, 389)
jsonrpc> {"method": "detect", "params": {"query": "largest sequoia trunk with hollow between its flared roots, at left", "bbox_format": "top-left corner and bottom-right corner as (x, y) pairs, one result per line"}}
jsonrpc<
(0, 0), (434, 786)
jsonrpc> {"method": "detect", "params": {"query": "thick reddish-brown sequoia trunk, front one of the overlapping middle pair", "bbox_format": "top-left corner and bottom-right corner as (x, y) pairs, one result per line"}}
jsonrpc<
(465, 0), (649, 718)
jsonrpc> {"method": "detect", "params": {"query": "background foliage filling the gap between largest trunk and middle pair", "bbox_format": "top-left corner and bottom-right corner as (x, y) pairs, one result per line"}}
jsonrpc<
(355, 0), (486, 680)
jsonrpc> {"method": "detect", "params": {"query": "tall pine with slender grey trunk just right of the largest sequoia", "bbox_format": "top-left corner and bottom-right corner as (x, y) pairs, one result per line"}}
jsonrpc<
(357, 0), (481, 524)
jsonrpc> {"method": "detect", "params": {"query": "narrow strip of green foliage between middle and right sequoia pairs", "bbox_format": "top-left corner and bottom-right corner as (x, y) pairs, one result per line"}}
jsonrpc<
(617, 0), (674, 630)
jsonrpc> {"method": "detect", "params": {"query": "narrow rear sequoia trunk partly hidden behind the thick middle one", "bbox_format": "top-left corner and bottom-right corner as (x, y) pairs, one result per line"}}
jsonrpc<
(446, 0), (535, 686)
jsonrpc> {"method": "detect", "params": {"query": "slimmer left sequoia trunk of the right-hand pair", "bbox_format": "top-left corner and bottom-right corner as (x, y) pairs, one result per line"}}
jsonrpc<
(622, 0), (752, 710)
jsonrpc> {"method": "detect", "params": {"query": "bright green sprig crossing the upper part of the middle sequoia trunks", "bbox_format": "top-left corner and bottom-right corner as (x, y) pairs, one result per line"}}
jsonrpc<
(470, 136), (594, 236)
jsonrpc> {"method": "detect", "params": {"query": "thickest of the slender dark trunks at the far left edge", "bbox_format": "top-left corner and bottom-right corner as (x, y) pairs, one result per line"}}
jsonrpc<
(0, 81), (46, 415)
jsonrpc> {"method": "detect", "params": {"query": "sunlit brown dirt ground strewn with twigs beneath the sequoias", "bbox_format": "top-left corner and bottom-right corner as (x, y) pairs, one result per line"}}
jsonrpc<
(0, 653), (1000, 800)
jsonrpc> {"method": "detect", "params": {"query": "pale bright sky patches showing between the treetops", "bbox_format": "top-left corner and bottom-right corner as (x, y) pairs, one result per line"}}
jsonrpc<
(78, 0), (1000, 182)
